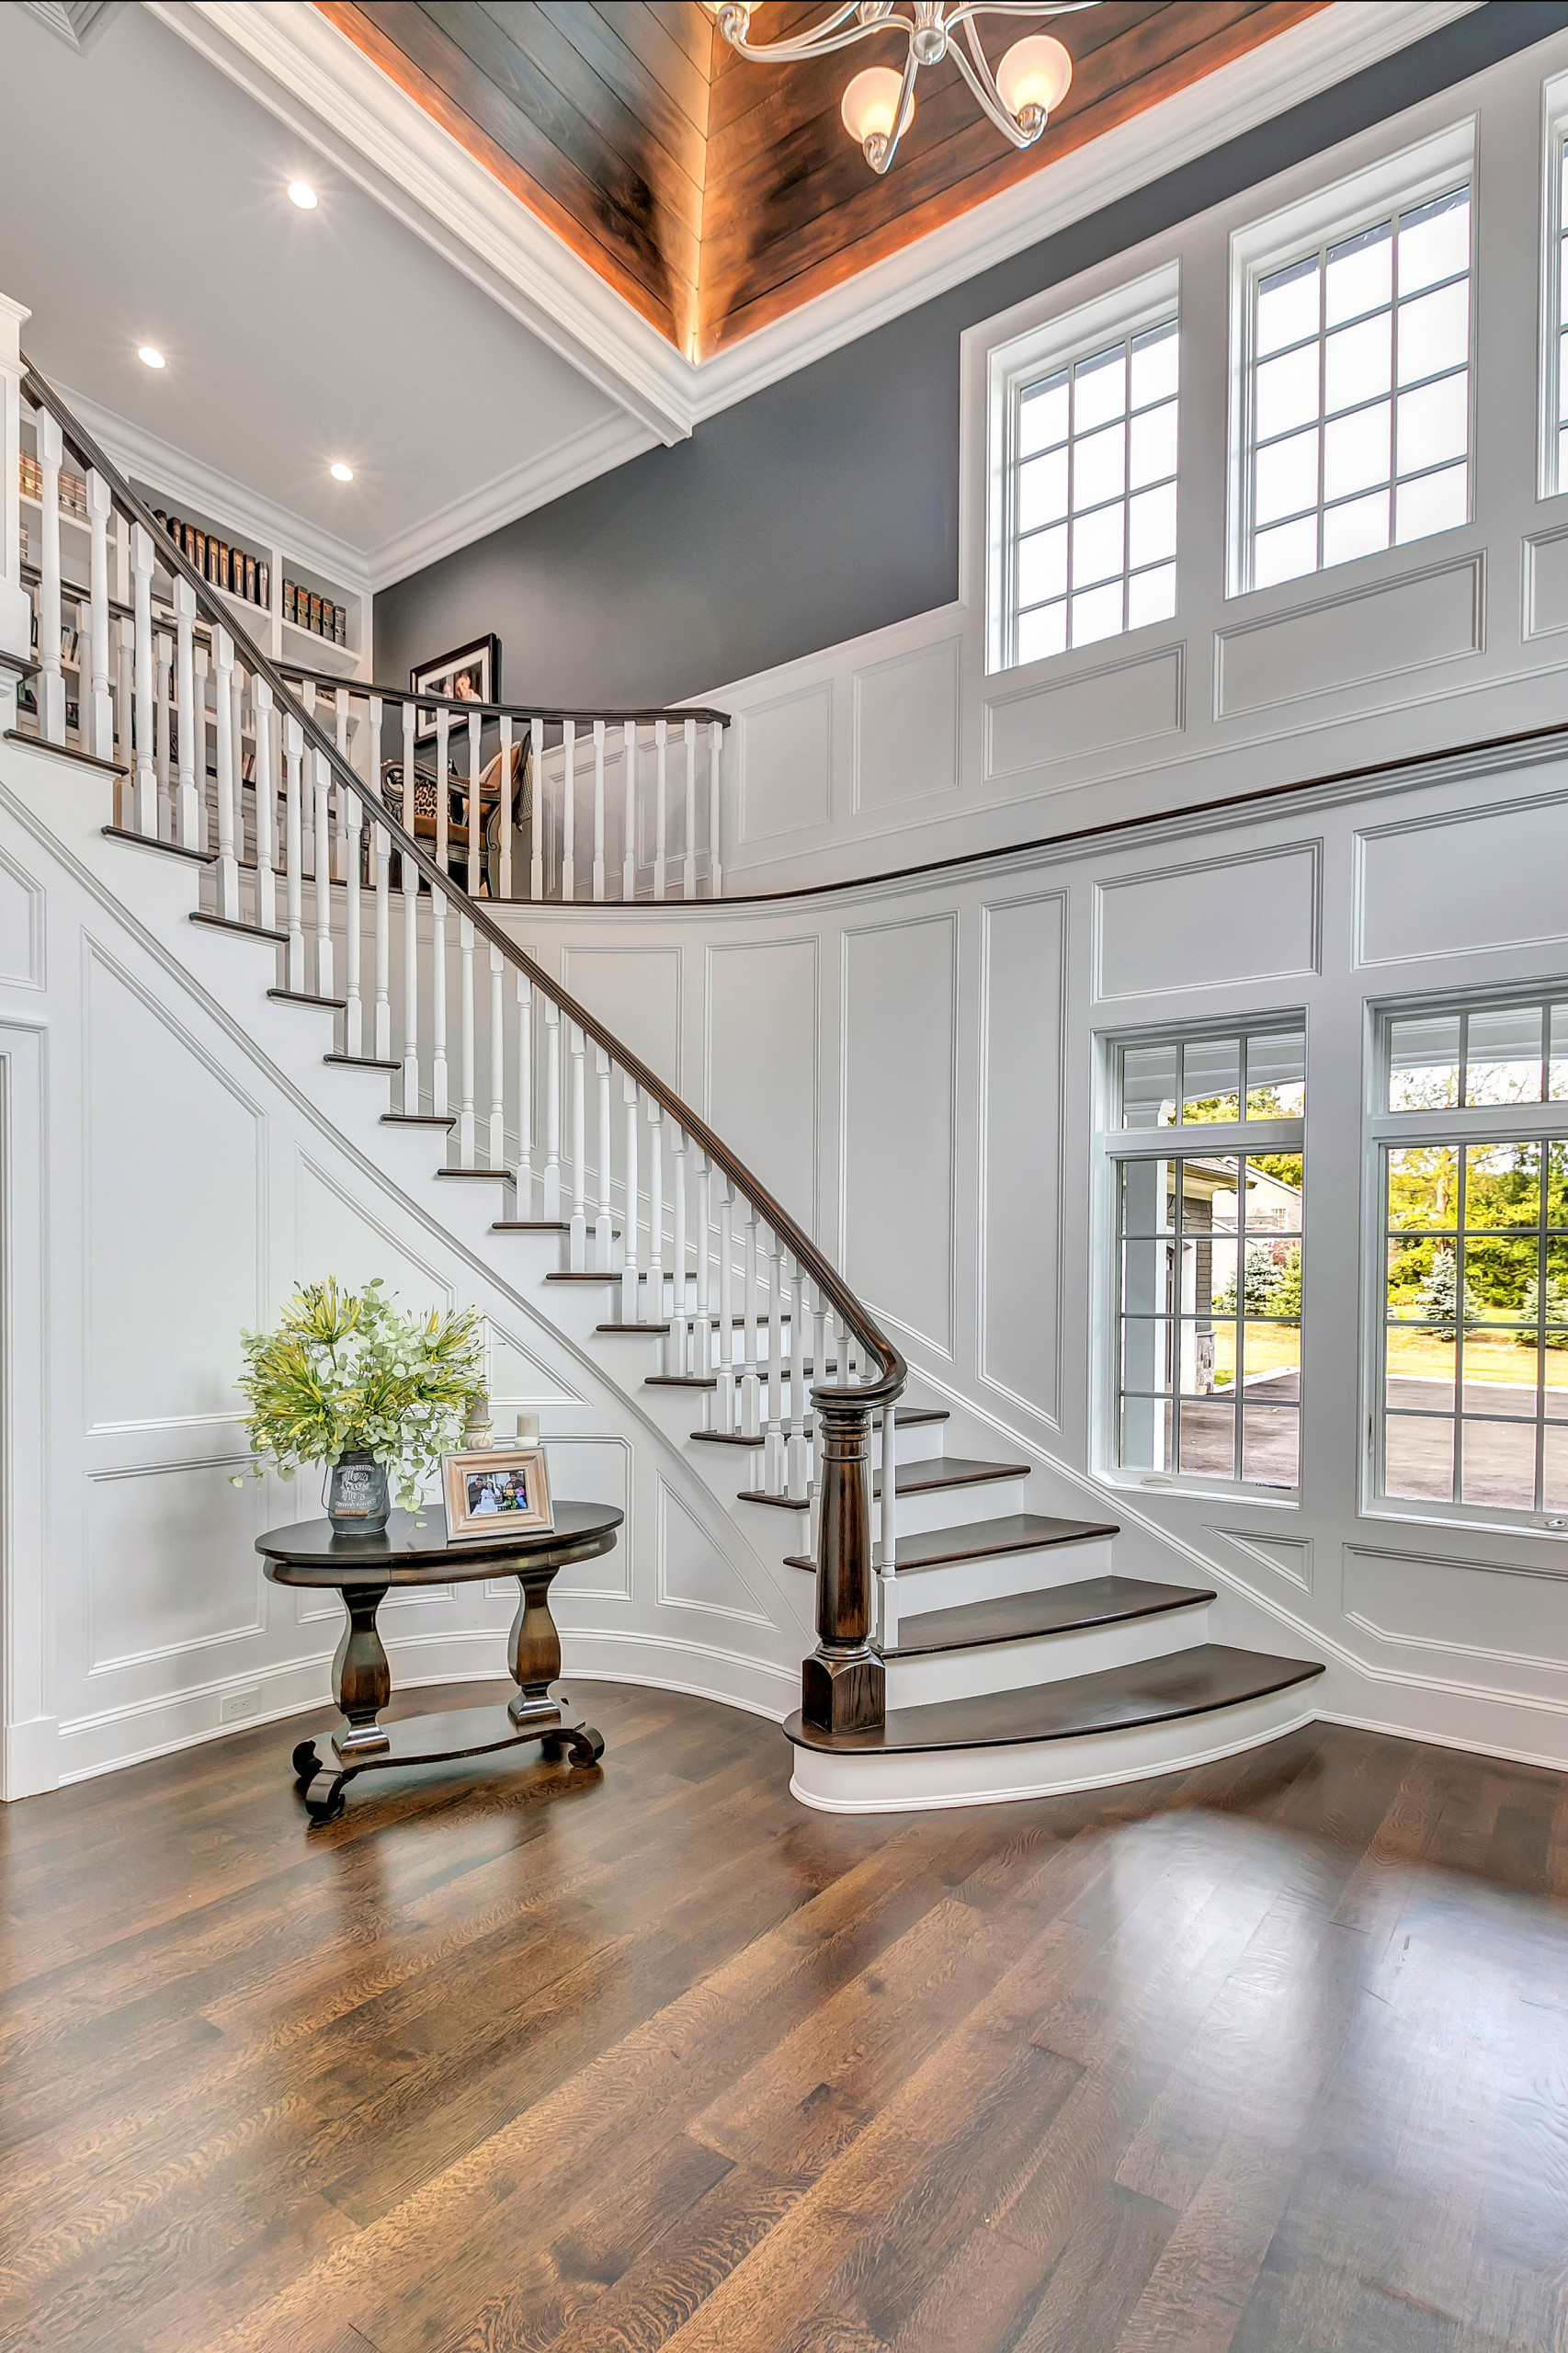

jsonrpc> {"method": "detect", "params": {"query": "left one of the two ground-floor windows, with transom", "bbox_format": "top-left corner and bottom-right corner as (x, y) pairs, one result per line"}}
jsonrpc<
(1108, 1018), (1307, 1489)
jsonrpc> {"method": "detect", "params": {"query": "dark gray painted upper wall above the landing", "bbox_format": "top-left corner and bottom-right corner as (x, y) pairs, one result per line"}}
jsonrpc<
(374, 0), (1568, 706)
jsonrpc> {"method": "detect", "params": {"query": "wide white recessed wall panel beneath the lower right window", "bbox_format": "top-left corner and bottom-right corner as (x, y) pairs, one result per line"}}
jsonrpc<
(1342, 1543), (1568, 1680)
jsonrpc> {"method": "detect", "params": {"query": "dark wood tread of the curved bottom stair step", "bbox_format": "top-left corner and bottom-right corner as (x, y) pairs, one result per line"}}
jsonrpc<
(784, 1643), (1324, 1756)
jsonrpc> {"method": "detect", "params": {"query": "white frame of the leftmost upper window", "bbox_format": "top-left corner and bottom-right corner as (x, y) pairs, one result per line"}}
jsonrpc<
(986, 259), (1182, 676)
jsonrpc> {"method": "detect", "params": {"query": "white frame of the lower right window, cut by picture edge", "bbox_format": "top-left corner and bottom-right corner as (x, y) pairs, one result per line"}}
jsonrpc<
(1361, 976), (1568, 1539)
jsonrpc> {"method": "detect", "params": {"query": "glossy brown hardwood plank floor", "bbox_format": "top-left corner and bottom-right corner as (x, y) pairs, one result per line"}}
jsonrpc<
(0, 1682), (1568, 2353)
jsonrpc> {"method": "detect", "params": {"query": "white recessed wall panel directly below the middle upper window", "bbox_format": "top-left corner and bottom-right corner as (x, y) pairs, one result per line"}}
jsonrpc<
(1215, 551), (1485, 720)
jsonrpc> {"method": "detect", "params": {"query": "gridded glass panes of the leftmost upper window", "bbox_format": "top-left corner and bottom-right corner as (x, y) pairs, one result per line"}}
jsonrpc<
(1006, 315), (1179, 665)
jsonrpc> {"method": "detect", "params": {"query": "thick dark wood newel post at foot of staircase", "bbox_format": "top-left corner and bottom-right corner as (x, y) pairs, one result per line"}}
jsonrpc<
(801, 1395), (888, 1732)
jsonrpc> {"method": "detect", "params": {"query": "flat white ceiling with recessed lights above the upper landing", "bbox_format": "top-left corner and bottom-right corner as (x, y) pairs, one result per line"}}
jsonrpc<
(0, 7), (635, 581)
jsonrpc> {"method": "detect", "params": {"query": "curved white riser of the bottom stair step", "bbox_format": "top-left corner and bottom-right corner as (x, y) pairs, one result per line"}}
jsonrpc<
(789, 1682), (1316, 1814)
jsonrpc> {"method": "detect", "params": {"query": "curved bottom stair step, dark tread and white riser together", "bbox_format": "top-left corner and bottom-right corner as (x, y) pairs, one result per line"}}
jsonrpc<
(784, 1644), (1324, 1814)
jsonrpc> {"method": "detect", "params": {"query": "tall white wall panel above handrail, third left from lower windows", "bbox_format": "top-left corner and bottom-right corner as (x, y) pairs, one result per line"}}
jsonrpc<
(704, 938), (822, 1233)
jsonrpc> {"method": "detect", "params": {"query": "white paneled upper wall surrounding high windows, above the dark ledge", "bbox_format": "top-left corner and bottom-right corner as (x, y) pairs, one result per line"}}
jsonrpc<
(682, 33), (1568, 892)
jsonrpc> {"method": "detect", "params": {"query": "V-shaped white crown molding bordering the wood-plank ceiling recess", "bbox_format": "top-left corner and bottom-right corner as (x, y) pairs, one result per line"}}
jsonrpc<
(148, 0), (1481, 442)
